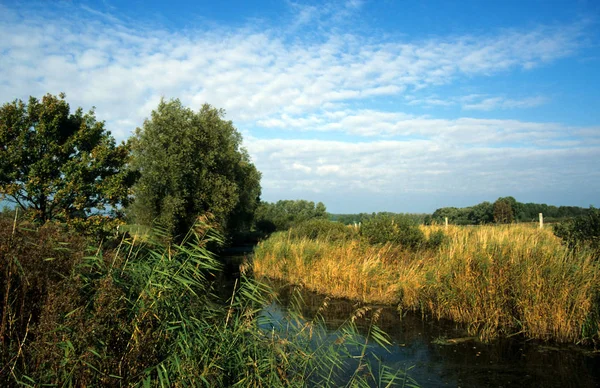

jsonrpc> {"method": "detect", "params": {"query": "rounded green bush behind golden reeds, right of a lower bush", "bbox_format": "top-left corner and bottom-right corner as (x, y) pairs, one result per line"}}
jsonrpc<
(360, 214), (425, 248)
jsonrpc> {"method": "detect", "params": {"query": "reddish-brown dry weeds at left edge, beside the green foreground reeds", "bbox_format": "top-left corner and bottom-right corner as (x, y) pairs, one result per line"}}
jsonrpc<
(0, 217), (85, 386)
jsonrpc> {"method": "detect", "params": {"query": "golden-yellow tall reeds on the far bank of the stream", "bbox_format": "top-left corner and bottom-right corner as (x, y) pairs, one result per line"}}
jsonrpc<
(253, 225), (600, 342)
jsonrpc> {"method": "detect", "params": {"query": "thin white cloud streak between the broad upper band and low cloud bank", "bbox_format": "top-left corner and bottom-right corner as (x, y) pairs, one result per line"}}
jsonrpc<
(258, 109), (588, 148)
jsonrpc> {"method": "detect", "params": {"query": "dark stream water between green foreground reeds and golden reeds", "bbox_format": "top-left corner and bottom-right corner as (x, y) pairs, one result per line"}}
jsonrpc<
(263, 282), (600, 387)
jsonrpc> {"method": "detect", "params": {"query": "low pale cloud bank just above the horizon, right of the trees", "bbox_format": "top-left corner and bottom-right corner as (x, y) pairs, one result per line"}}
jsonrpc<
(248, 138), (600, 194)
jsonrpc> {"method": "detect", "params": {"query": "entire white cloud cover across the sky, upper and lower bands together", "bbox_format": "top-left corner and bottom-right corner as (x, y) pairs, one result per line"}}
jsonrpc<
(0, 1), (600, 212)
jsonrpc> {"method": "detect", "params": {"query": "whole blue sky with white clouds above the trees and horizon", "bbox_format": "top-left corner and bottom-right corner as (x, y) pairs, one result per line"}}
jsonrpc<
(0, 0), (600, 213)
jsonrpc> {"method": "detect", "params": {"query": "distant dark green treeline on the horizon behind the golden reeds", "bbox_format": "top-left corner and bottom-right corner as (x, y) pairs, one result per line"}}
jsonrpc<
(329, 197), (590, 225)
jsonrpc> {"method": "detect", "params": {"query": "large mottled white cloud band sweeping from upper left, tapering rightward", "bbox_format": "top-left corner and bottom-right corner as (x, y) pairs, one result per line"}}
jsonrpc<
(0, 2), (580, 137)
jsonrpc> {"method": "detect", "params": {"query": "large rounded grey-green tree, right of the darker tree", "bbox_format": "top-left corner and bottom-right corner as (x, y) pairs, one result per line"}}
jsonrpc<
(132, 99), (260, 237)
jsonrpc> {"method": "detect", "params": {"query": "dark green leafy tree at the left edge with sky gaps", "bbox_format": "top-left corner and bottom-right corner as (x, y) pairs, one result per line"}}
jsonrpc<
(0, 93), (135, 222)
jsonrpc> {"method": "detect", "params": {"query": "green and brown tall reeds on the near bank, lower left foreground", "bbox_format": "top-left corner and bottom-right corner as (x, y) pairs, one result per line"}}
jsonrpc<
(0, 220), (411, 387)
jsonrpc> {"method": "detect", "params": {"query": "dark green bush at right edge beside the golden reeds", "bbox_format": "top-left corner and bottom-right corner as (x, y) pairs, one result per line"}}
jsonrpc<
(554, 208), (600, 250)
